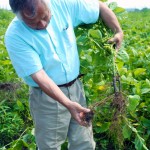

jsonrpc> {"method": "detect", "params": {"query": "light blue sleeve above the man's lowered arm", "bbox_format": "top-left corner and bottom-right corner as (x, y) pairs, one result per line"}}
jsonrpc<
(5, 34), (42, 78)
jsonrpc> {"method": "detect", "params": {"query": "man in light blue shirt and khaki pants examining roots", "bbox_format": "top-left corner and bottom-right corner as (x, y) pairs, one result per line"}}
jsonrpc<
(5, 0), (123, 150)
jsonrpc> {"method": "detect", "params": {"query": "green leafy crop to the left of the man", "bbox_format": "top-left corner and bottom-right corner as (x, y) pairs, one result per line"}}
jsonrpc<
(0, 10), (36, 150)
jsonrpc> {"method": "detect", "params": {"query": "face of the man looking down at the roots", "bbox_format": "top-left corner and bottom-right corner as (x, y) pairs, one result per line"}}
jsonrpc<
(21, 1), (51, 30)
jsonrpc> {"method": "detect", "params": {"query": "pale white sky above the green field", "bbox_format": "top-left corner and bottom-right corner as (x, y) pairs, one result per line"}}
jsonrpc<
(0, 0), (150, 9)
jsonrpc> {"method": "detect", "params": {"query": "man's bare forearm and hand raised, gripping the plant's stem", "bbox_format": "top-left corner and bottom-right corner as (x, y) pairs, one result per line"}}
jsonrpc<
(99, 2), (123, 50)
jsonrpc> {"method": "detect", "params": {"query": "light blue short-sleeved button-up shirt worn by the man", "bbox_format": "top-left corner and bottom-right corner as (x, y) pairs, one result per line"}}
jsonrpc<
(5, 0), (99, 87)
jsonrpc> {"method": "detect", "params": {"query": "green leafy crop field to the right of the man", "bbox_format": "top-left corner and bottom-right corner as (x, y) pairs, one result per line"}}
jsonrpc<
(76, 6), (150, 150)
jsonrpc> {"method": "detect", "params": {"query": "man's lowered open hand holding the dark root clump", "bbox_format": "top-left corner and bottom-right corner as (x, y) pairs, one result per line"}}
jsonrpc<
(68, 101), (90, 127)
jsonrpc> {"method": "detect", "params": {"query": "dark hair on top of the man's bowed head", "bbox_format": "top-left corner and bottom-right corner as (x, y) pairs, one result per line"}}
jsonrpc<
(9, 0), (38, 15)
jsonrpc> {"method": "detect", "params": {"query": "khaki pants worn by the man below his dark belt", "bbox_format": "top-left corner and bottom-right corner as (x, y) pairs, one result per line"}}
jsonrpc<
(29, 80), (95, 150)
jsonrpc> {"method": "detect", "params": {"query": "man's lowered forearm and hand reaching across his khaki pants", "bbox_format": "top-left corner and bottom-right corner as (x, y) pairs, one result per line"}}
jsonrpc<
(31, 69), (90, 126)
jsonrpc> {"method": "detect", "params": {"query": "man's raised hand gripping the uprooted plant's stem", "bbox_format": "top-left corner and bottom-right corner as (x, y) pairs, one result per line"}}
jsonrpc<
(108, 32), (123, 51)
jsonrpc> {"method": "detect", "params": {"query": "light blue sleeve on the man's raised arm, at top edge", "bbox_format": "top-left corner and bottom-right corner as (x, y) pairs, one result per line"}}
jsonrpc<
(66, 0), (100, 26)
